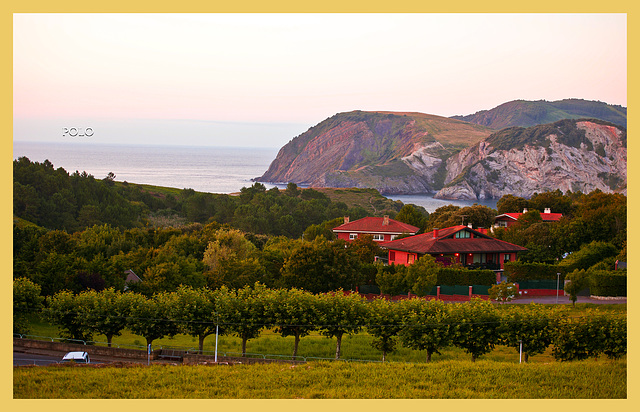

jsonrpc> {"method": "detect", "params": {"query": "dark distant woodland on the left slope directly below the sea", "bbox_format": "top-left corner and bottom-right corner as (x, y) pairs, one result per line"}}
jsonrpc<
(13, 157), (397, 238)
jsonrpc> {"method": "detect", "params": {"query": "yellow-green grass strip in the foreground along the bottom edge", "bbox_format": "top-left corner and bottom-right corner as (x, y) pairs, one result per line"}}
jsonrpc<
(13, 360), (627, 399)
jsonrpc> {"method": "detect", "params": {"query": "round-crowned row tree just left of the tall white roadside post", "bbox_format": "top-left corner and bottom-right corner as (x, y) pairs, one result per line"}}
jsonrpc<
(170, 285), (216, 353)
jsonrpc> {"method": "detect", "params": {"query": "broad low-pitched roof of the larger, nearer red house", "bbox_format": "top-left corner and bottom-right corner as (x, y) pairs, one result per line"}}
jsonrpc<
(380, 225), (527, 255)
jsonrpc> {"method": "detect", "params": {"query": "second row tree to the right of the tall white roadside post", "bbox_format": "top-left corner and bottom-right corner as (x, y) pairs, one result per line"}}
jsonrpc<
(267, 288), (320, 360)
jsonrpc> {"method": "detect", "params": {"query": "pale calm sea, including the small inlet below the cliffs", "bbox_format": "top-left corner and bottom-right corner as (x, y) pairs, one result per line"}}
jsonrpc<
(13, 141), (497, 213)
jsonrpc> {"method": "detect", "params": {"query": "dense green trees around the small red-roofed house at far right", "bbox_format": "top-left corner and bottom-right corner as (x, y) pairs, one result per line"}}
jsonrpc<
(494, 190), (627, 270)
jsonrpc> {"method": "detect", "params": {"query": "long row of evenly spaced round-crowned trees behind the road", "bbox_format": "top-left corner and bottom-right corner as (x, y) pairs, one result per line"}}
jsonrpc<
(14, 279), (627, 362)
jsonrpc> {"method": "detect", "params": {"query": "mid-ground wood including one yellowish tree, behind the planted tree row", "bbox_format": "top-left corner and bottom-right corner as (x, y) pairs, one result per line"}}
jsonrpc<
(13, 222), (382, 296)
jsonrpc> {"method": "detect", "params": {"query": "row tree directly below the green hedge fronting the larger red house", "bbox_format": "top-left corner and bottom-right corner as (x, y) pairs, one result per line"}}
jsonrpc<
(450, 299), (500, 362)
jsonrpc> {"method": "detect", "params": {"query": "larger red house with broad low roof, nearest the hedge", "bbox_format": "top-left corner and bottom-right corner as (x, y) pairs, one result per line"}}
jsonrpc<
(380, 225), (527, 271)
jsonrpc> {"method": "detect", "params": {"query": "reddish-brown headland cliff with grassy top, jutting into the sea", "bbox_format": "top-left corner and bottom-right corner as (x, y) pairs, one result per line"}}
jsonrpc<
(256, 111), (491, 194)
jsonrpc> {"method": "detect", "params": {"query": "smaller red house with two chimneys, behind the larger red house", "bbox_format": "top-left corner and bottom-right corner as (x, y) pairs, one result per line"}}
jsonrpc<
(333, 216), (420, 242)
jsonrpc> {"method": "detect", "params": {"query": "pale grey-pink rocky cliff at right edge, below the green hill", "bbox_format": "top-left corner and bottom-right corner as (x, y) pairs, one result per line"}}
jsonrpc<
(435, 121), (627, 200)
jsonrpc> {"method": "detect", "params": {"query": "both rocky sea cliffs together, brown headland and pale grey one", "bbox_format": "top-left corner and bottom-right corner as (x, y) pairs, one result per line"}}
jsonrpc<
(255, 111), (627, 200)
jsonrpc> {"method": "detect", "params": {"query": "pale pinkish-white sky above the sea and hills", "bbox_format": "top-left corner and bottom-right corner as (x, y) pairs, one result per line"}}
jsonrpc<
(13, 14), (627, 147)
